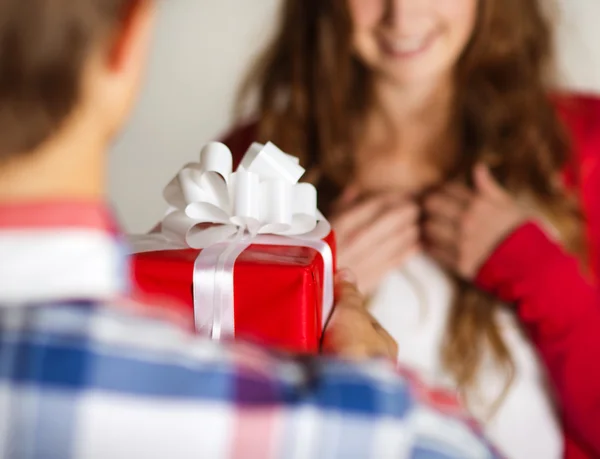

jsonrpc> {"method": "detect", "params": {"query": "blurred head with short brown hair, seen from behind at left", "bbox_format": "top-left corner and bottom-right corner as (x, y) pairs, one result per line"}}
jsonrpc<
(0, 0), (154, 169)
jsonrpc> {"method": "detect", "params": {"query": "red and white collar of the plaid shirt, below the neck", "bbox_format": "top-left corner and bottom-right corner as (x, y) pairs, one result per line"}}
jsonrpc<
(0, 201), (130, 304)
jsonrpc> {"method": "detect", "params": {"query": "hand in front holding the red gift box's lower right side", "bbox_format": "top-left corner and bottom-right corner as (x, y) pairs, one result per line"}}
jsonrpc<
(322, 271), (398, 361)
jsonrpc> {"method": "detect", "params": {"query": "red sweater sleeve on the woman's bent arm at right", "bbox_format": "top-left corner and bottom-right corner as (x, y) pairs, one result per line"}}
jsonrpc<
(478, 223), (600, 455)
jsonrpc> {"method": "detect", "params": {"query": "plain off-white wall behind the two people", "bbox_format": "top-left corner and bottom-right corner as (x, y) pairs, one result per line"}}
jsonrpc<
(109, 0), (600, 232)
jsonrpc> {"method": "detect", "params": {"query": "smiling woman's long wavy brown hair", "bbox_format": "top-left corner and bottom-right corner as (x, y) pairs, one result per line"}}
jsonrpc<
(237, 0), (584, 416)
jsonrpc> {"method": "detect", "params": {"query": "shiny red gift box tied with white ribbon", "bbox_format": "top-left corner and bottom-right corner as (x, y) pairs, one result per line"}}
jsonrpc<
(133, 233), (335, 353)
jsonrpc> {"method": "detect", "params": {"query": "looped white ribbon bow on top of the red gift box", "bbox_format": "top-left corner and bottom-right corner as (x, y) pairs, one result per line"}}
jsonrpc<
(162, 142), (331, 249)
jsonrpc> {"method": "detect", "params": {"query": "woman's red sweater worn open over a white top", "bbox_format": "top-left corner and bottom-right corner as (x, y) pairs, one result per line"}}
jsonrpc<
(224, 92), (600, 459)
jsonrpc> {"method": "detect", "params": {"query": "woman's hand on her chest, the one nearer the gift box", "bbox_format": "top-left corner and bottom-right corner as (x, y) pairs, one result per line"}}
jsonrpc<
(330, 191), (420, 295)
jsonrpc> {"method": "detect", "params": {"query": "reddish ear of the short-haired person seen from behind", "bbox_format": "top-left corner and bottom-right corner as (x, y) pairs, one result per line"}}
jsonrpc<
(107, 0), (156, 72)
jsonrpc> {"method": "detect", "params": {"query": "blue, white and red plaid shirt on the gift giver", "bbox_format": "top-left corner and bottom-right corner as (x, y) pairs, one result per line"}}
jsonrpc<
(0, 203), (496, 459)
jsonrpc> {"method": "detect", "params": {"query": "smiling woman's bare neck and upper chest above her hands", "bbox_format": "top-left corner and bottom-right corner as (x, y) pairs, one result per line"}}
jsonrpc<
(355, 74), (457, 195)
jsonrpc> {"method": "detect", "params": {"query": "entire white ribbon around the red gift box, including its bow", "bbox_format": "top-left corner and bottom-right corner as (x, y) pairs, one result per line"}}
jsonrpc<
(130, 142), (333, 339)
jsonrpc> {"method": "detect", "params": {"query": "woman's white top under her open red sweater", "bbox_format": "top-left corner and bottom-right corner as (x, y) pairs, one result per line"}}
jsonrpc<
(371, 254), (563, 459)
